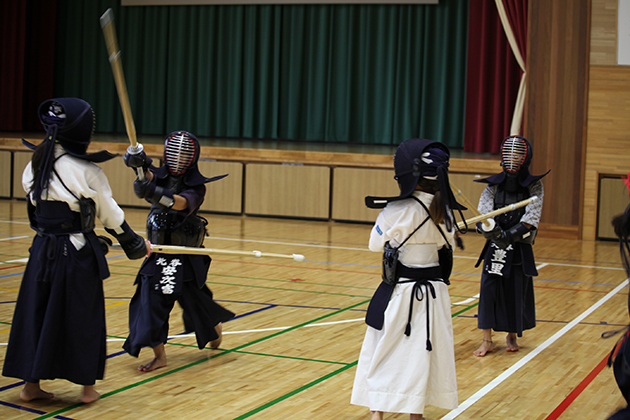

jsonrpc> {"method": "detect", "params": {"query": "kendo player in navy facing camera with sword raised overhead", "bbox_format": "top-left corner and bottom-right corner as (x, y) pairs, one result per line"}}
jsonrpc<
(123, 131), (234, 372)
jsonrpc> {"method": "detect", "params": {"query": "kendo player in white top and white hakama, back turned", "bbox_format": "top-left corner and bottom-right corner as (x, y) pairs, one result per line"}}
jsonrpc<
(350, 139), (465, 420)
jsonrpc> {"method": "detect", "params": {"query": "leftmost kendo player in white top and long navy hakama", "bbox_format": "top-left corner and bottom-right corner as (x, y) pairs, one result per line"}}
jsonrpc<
(2, 98), (147, 403)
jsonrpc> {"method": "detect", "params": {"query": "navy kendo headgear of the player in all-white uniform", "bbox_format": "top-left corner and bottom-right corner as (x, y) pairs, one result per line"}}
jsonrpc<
(365, 139), (466, 230)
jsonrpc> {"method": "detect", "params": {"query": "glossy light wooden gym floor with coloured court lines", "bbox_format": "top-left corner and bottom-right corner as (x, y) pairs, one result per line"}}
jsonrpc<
(0, 200), (628, 420)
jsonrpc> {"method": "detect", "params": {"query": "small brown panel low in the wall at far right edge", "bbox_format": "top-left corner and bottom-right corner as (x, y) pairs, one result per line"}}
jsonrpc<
(597, 178), (630, 239)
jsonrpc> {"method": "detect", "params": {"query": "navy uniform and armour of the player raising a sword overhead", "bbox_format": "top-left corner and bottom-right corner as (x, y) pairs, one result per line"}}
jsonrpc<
(123, 132), (234, 357)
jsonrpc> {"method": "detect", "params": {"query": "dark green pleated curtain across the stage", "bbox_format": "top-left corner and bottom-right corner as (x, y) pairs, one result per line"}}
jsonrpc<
(55, 0), (468, 148)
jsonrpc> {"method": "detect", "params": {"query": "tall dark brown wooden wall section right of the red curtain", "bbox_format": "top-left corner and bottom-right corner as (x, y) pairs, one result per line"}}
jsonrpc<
(524, 0), (590, 238)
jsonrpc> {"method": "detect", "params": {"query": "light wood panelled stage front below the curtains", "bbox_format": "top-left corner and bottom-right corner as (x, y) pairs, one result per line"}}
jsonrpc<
(0, 138), (528, 223)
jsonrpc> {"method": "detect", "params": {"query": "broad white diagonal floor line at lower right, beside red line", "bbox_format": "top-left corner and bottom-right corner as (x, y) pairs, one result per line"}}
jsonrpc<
(442, 279), (628, 420)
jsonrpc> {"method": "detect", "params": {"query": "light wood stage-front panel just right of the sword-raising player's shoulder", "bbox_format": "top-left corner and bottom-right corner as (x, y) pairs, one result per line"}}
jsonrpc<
(199, 160), (243, 214)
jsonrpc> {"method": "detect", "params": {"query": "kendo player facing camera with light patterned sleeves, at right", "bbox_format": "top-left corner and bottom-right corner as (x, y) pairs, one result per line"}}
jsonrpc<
(473, 136), (549, 357)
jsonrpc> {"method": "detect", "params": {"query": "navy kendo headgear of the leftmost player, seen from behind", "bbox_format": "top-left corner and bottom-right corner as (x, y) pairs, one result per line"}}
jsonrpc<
(22, 98), (117, 200)
